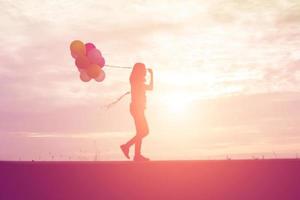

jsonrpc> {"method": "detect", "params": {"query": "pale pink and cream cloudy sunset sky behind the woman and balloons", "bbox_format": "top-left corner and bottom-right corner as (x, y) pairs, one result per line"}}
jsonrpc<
(0, 0), (300, 160)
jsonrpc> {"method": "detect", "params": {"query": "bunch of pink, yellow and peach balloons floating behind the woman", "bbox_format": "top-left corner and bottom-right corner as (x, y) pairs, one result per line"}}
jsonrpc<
(70, 40), (105, 82)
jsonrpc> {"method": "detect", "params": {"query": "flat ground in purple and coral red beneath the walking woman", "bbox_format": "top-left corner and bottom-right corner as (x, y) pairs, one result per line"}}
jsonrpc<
(0, 159), (300, 200)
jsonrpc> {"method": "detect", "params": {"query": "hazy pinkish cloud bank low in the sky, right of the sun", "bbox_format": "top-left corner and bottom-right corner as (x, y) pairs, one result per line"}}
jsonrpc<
(190, 92), (300, 133)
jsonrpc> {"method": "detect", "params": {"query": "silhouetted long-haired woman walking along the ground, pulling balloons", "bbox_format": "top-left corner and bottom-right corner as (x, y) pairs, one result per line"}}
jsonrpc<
(120, 63), (153, 161)
